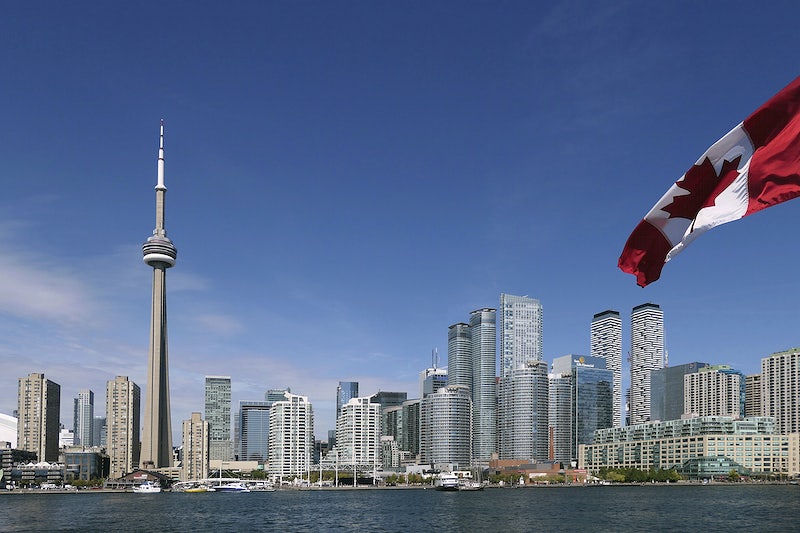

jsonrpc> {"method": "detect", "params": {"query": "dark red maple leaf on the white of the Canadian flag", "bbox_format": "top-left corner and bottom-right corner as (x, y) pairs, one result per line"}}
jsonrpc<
(661, 156), (742, 220)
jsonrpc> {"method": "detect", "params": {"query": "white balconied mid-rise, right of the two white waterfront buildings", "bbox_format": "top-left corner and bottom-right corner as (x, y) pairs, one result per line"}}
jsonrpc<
(335, 397), (381, 471)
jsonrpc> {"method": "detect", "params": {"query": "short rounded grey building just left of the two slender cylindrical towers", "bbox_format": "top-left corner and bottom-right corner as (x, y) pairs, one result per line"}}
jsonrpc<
(420, 385), (473, 469)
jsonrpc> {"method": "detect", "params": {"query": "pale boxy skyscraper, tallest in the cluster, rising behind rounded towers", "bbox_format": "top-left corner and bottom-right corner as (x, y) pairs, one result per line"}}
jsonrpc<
(500, 294), (542, 377)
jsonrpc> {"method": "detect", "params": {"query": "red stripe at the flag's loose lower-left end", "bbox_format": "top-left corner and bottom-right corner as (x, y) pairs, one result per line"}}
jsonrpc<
(618, 220), (672, 287)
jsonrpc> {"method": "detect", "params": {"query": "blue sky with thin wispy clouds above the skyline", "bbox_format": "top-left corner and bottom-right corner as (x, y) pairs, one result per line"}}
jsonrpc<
(0, 1), (800, 437)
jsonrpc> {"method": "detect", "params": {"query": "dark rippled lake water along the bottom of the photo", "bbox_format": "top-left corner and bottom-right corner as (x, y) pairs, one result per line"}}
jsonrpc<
(0, 485), (800, 532)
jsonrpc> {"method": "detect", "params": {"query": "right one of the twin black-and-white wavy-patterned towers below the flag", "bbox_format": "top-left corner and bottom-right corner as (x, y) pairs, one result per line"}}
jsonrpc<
(630, 303), (664, 424)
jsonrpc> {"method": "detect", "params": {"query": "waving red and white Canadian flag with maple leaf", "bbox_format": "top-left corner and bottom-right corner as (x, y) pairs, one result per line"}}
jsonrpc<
(619, 78), (800, 287)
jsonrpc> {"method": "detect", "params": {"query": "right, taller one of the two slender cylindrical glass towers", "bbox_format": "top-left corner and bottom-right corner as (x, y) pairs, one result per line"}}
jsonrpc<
(469, 308), (497, 463)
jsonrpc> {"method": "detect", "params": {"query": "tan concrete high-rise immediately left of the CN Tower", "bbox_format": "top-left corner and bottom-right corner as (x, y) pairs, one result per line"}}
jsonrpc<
(106, 376), (141, 479)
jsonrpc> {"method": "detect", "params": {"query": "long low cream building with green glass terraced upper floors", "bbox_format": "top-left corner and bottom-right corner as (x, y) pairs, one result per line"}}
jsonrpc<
(578, 416), (800, 474)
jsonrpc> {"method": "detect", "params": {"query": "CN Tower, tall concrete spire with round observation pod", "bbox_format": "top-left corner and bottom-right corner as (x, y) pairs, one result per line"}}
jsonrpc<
(140, 120), (178, 469)
